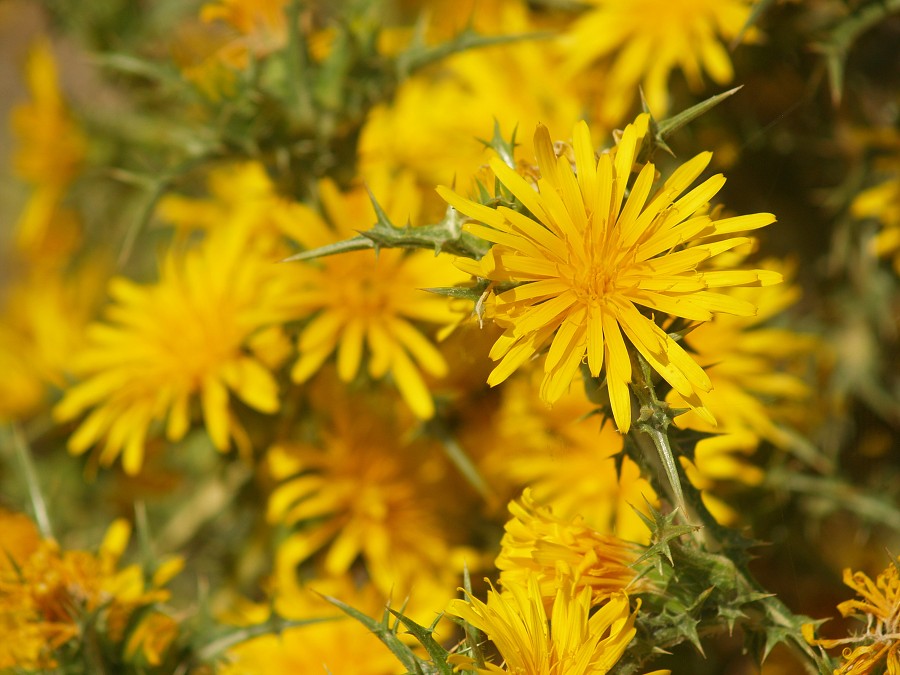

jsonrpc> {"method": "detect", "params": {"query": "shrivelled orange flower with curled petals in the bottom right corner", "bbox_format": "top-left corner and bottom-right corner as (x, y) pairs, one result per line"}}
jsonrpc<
(803, 559), (900, 675)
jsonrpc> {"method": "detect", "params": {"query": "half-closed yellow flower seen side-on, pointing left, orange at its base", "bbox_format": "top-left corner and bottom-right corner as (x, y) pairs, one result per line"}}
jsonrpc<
(496, 489), (641, 607)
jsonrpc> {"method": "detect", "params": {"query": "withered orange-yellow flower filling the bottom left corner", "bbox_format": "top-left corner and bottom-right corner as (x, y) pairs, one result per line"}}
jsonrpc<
(0, 511), (182, 670)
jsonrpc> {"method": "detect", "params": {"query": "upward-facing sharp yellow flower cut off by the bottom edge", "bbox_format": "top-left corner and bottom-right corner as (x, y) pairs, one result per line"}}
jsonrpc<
(447, 575), (637, 675)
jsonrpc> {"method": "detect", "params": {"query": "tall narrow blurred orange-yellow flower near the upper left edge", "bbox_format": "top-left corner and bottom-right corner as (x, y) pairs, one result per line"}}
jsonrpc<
(11, 40), (87, 260)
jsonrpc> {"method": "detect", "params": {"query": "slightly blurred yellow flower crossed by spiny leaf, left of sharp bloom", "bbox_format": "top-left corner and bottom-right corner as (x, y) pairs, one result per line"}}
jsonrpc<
(291, 181), (463, 419)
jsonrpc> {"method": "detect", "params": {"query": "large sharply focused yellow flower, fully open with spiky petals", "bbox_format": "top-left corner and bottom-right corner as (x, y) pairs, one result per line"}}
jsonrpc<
(438, 115), (781, 432)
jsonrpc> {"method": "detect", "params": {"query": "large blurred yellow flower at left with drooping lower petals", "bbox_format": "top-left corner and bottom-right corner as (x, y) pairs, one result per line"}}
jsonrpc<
(54, 227), (293, 474)
